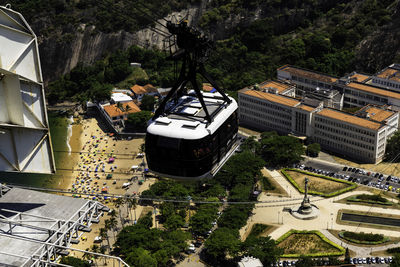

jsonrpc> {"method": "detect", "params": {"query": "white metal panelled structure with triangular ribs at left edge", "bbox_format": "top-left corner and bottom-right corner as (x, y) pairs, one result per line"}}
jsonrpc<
(0, 6), (55, 173)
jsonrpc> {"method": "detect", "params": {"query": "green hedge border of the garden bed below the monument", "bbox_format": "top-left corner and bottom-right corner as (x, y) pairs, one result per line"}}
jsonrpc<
(275, 229), (346, 258)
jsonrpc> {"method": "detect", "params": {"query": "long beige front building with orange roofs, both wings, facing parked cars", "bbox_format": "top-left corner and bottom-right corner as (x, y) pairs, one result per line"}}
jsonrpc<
(238, 88), (399, 163)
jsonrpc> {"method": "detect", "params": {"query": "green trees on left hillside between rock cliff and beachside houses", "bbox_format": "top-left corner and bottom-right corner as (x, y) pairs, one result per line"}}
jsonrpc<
(47, 46), (174, 104)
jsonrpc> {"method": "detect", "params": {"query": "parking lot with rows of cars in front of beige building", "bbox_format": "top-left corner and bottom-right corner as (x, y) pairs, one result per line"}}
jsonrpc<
(295, 160), (400, 193)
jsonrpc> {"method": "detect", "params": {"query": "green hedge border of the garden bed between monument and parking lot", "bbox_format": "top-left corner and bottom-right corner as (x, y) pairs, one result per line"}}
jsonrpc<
(281, 168), (357, 197)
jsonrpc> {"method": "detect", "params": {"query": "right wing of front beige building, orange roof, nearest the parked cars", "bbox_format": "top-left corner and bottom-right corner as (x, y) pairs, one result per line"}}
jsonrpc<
(312, 106), (399, 163)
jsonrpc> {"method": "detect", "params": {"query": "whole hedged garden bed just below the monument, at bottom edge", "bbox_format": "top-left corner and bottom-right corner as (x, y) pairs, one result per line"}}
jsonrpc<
(276, 230), (345, 258)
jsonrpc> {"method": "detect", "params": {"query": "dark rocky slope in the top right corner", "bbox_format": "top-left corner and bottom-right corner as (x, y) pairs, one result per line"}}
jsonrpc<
(355, 2), (400, 73)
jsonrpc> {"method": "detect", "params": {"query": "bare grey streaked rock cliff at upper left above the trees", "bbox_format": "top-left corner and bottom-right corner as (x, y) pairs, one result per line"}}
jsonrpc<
(37, 0), (206, 83)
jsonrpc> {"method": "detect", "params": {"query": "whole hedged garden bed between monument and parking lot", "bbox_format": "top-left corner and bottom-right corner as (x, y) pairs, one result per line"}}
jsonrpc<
(281, 168), (357, 197)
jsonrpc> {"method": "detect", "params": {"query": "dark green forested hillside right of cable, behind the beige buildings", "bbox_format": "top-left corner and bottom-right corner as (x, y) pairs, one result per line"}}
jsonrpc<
(205, 0), (397, 90)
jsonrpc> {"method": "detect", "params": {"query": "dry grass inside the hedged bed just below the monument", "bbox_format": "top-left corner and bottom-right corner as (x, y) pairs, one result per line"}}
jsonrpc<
(278, 233), (340, 255)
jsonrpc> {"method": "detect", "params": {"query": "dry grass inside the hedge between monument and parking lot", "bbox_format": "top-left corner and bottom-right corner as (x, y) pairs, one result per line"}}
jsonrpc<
(286, 170), (349, 194)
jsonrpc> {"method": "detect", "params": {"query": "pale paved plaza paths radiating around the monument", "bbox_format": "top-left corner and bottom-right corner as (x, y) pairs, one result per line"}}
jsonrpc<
(240, 170), (400, 257)
